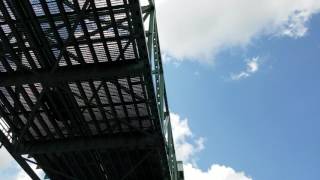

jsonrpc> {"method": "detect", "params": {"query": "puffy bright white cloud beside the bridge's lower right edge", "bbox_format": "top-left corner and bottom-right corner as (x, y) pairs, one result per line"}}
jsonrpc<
(170, 113), (252, 180)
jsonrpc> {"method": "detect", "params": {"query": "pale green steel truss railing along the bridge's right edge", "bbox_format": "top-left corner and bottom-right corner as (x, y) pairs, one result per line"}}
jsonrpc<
(142, 0), (183, 180)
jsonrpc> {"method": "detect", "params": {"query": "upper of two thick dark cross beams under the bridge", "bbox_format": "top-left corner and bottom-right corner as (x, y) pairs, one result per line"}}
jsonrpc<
(0, 60), (149, 87)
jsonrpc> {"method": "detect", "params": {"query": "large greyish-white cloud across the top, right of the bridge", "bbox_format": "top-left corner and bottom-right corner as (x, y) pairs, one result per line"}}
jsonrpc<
(156, 0), (320, 62)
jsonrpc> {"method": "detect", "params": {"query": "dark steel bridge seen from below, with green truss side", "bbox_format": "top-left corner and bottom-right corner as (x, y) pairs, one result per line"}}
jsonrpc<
(0, 0), (184, 180)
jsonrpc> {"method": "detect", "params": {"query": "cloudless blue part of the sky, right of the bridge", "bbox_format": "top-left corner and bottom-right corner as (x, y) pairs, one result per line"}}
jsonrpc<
(159, 0), (320, 180)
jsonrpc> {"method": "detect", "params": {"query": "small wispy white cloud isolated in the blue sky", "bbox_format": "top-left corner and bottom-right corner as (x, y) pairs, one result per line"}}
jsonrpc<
(231, 56), (261, 80)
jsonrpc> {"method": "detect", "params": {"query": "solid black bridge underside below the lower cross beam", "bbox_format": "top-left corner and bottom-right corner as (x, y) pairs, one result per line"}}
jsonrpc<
(35, 150), (163, 180)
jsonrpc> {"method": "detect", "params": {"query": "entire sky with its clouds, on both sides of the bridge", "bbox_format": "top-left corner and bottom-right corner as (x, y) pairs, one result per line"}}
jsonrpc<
(0, 0), (320, 180)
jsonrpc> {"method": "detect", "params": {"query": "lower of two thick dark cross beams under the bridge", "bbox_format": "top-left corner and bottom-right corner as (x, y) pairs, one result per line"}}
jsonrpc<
(17, 133), (161, 154)
